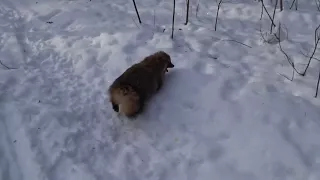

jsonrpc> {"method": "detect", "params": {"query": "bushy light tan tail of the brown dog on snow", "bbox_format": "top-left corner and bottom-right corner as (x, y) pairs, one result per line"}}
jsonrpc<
(109, 86), (140, 117)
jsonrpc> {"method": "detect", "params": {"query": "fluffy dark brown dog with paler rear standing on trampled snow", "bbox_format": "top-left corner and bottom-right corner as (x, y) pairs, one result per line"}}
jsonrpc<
(108, 51), (174, 117)
